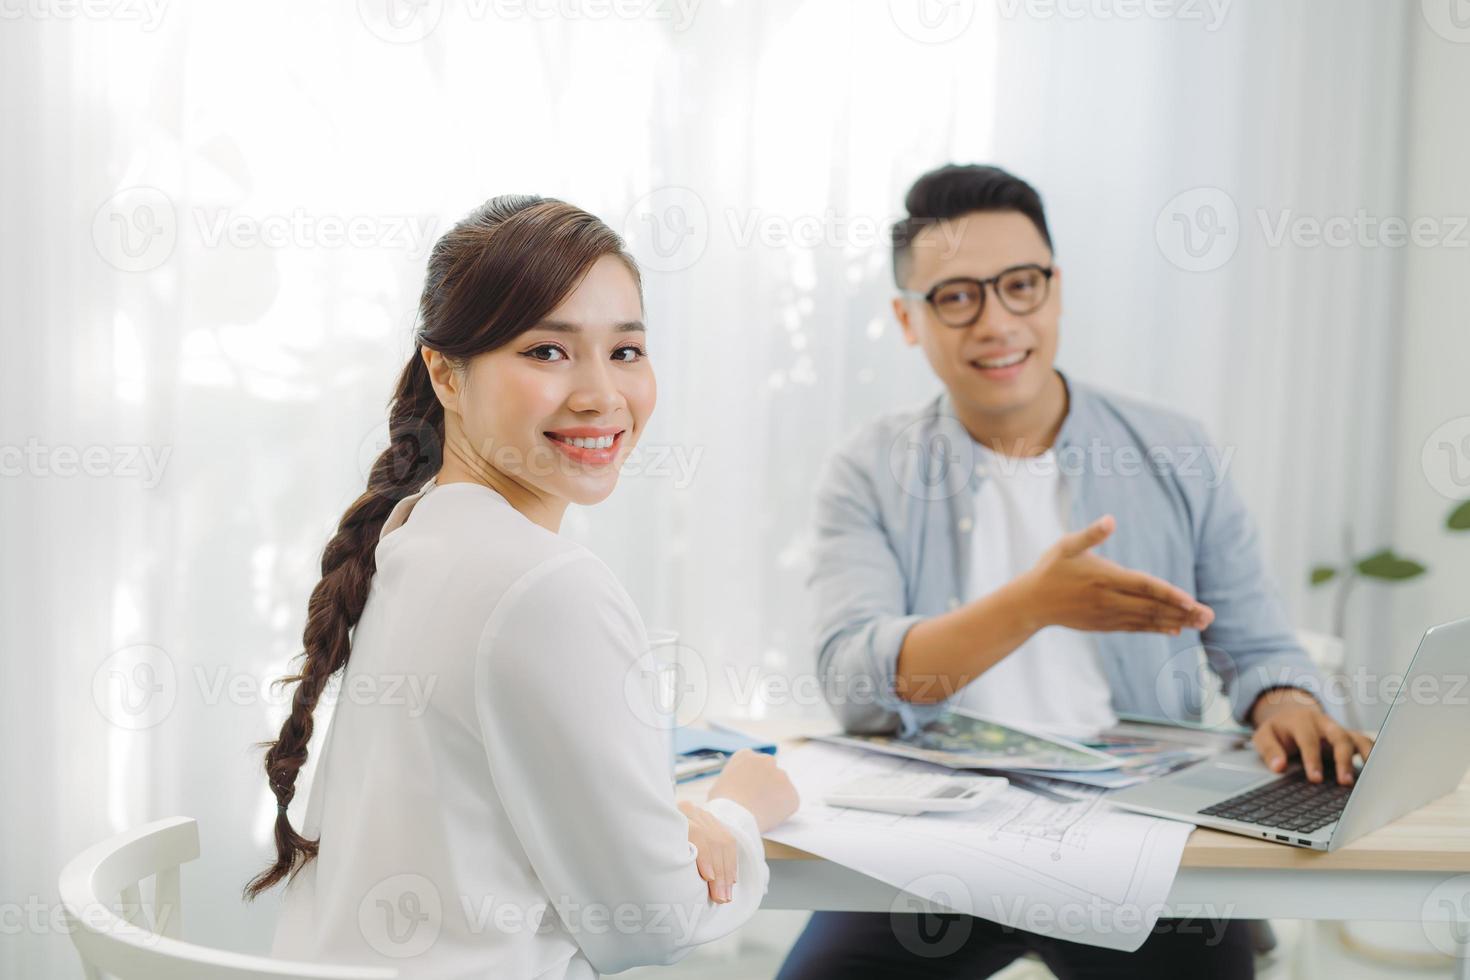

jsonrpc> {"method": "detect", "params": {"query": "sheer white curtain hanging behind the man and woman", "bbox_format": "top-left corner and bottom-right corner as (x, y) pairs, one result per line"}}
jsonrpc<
(0, 0), (1405, 977)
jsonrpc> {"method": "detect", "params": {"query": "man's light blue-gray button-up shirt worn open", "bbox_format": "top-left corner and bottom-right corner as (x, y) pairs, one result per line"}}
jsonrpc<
(809, 379), (1322, 732)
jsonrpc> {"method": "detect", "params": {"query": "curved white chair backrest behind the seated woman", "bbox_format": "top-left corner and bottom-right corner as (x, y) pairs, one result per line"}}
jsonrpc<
(60, 817), (398, 980)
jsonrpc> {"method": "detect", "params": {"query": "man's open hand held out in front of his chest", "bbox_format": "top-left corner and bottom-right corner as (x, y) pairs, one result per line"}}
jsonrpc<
(1020, 514), (1214, 636)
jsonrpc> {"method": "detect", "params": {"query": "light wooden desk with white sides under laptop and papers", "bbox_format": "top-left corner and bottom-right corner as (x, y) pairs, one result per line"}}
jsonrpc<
(679, 726), (1470, 980)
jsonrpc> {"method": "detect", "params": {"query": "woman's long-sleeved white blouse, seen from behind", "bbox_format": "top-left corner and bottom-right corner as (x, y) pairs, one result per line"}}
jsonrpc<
(272, 480), (770, 979)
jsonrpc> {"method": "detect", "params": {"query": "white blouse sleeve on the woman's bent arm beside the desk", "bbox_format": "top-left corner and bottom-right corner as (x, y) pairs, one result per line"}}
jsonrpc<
(475, 551), (770, 973)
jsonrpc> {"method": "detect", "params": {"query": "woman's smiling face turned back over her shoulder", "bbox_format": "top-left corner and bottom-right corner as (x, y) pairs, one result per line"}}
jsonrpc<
(429, 256), (657, 514)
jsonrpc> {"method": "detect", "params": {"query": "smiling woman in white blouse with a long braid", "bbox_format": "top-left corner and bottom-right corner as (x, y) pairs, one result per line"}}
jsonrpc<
(245, 197), (797, 977)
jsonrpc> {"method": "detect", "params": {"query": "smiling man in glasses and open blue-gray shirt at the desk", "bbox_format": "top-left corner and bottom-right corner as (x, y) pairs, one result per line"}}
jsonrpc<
(781, 166), (1370, 980)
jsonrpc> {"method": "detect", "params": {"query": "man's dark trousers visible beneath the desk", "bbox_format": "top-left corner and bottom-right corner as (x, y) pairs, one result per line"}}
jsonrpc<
(778, 912), (1255, 980)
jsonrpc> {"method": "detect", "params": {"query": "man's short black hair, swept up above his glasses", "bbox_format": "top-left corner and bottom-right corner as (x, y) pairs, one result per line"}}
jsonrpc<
(892, 163), (1051, 287)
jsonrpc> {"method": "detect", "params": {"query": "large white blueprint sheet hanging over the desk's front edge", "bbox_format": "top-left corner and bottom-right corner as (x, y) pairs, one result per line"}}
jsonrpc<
(766, 742), (1192, 951)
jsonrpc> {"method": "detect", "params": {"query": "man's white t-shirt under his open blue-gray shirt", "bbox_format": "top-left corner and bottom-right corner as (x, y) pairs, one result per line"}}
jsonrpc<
(954, 444), (1117, 736)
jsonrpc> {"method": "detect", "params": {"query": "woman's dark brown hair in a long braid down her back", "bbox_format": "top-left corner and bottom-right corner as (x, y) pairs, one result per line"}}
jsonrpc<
(245, 194), (641, 899)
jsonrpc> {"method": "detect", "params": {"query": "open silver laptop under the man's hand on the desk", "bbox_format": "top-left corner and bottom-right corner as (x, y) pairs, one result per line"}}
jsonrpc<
(1108, 619), (1470, 851)
